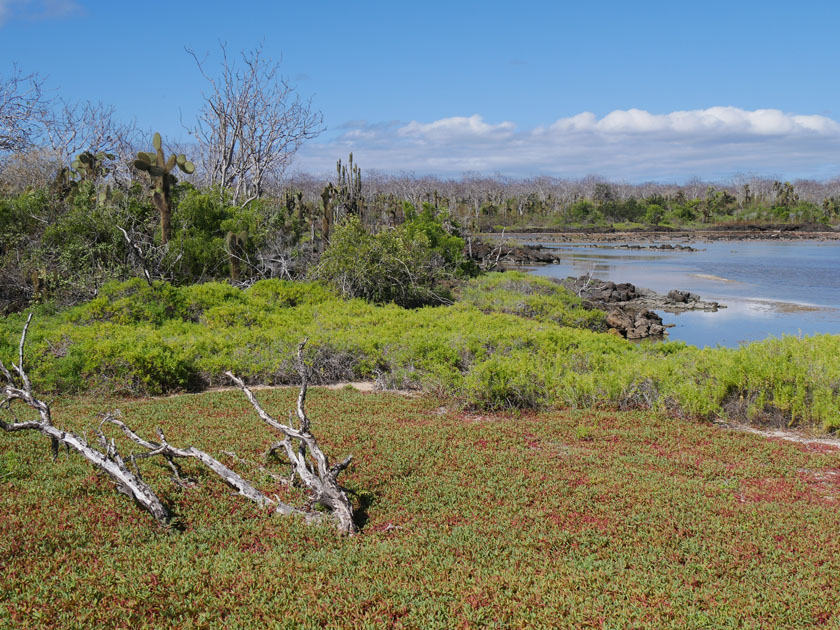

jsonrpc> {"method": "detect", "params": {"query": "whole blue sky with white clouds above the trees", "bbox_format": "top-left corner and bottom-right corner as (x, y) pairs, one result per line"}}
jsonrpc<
(0, 0), (840, 182)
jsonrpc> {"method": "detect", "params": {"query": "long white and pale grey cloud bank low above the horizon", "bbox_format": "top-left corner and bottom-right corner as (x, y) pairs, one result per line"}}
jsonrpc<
(295, 107), (840, 181)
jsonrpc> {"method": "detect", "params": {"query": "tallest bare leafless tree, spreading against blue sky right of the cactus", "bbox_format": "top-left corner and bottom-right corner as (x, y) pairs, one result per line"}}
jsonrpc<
(187, 45), (323, 205)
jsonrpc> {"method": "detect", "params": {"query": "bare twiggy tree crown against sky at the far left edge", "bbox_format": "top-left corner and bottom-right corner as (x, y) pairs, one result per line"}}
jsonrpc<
(0, 67), (49, 152)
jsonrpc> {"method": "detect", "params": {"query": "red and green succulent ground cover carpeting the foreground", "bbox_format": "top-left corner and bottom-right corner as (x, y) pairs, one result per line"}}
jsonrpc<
(0, 388), (840, 628)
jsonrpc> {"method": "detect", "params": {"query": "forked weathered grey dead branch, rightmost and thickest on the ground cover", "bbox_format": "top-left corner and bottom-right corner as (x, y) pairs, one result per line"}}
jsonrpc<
(225, 340), (356, 534)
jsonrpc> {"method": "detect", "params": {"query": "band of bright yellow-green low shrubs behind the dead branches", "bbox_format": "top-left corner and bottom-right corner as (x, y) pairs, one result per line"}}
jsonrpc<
(0, 272), (840, 430)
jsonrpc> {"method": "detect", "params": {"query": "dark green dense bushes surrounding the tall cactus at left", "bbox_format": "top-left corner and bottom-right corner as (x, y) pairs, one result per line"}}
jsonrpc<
(0, 181), (312, 313)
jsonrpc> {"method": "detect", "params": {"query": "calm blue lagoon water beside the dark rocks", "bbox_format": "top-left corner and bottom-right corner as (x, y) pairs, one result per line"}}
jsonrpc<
(533, 241), (840, 347)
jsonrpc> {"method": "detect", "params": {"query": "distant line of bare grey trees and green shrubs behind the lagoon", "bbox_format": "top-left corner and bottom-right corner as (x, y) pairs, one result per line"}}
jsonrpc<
(286, 172), (840, 231)
